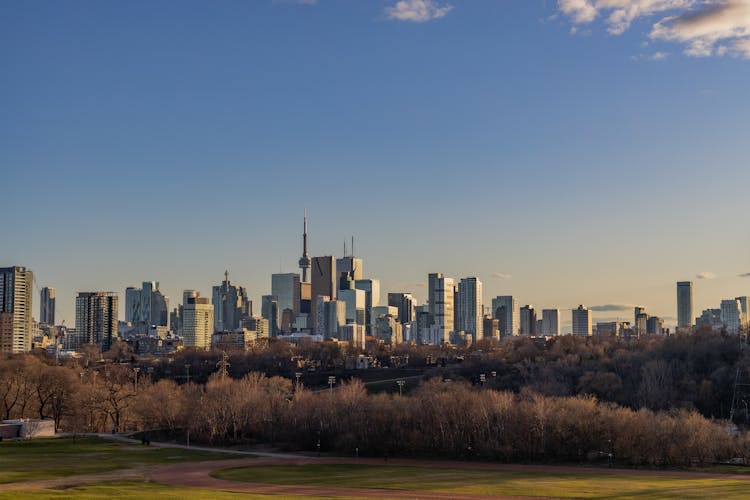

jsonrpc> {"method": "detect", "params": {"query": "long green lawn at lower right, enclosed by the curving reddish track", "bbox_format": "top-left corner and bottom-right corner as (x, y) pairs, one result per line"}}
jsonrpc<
(212, 464), (750, 499)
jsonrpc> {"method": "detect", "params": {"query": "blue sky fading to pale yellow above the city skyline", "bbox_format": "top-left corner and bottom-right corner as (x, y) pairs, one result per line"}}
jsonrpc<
(0, 0), (750, 332)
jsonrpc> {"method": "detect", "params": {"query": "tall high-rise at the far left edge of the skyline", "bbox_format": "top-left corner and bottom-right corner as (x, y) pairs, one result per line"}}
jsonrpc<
(0, 266), (34, 354)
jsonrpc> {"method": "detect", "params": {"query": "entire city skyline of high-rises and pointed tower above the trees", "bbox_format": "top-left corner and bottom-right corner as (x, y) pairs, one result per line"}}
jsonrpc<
(0, 217), (750, 353)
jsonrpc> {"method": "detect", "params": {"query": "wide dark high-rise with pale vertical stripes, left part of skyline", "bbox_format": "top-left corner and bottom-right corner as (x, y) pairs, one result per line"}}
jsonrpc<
(76, 292), (118, 351)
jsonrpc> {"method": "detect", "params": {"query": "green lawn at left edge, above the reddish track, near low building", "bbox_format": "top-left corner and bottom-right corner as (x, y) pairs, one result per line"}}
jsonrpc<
(0, 438), (229, 483)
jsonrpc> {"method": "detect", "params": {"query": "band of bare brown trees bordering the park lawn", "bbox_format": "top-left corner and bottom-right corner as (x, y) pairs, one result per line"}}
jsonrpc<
(0, 350), (750, 465)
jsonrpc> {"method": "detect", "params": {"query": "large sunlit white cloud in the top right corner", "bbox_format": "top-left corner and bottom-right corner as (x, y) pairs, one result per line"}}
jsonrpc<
(558, 0), (750, 60)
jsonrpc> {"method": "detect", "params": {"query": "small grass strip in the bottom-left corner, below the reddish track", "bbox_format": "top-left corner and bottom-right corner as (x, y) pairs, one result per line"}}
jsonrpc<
(0, 481), (364, 500)
